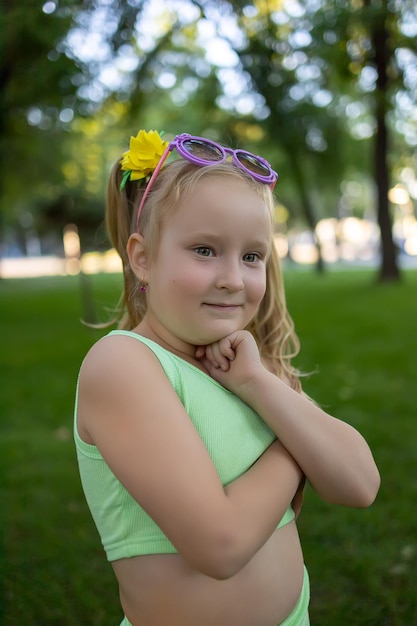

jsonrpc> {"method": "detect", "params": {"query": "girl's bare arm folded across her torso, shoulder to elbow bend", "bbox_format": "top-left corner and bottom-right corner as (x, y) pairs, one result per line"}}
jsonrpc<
(78, 336), (302, 579)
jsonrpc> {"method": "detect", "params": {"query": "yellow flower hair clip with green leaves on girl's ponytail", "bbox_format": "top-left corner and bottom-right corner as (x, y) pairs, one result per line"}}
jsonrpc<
(120, 130), (169, 191)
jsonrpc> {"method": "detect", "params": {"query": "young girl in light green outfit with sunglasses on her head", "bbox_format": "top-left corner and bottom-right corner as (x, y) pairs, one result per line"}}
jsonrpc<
(75, 131), (379, 626)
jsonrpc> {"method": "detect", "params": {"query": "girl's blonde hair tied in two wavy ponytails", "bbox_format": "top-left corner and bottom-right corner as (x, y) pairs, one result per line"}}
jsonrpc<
(106, 159), (301, 391)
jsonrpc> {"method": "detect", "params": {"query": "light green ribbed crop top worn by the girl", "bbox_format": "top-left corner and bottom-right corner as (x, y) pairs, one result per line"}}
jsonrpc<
(74, 330), (294, 561)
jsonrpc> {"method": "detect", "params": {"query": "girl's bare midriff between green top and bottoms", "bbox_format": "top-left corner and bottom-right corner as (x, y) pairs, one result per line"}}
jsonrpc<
(112, 522), (303, 626)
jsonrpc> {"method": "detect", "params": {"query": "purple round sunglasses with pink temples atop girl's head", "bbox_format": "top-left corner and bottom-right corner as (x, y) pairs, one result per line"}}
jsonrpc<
(137, 133), (278, 222)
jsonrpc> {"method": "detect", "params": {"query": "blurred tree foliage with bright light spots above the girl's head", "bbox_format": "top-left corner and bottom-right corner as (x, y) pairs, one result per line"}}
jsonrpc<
(0, 0), (417, 272)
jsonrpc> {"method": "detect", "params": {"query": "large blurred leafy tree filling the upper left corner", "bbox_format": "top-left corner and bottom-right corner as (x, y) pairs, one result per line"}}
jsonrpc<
(0, 0), (149, 252)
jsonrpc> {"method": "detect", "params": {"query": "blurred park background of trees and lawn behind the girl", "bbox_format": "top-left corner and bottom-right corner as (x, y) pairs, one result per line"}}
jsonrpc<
(0, 0), (417, 626)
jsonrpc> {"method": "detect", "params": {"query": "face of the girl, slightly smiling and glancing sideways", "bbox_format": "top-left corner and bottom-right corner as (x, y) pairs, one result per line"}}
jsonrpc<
(146, 177), (271, 354)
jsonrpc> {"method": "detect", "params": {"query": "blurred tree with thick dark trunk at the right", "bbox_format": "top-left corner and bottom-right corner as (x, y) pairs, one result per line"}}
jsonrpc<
(324, 0), (417, 280)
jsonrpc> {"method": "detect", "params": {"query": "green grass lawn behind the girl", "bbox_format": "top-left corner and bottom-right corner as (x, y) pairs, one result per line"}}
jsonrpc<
(0, 270), (417, 626)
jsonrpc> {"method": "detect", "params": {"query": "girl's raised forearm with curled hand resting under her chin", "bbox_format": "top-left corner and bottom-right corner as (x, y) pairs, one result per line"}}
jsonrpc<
(197, 331), (380, 507)
